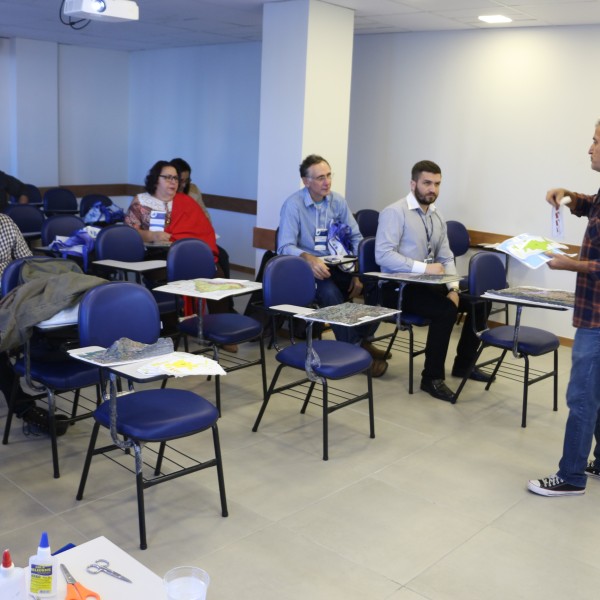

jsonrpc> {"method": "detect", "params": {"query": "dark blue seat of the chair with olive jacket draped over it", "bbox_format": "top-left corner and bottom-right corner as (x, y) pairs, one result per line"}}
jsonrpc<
(15, 358), (100, 391)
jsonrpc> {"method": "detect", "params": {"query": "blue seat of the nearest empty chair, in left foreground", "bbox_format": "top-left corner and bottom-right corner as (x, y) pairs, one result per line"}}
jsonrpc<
(94, 389), (219, 442)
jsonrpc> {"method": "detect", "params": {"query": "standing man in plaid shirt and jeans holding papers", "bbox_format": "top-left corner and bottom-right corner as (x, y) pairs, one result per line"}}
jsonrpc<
(527, 121), (600, 496)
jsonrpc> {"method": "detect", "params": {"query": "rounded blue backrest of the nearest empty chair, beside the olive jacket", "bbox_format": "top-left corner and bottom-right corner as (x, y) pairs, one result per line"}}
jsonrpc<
(79, 281), (160, 348)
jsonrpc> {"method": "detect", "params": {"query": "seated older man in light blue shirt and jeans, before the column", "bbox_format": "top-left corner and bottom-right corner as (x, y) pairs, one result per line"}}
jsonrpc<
(277, 154), (388, 377)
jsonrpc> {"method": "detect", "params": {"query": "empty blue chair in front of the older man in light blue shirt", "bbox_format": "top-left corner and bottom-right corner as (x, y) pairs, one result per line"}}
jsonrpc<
(252, 256), (375, 460)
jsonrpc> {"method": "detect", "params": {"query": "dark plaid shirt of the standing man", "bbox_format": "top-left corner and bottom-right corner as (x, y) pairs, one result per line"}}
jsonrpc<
(568, 191), (600, 328)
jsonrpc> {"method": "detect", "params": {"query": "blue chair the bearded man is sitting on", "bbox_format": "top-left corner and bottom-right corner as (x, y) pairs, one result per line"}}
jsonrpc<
(358, 237), (431, 394)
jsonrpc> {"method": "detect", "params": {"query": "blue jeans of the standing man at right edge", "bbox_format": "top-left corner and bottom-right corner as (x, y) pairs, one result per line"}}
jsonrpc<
(557, 328), (600, 487)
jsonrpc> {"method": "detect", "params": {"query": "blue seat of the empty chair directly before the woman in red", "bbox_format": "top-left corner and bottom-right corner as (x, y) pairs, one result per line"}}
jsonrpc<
(179, 313), (262, 344)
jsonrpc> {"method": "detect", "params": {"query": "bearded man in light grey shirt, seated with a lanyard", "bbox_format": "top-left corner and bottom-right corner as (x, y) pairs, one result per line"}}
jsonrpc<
(375, 160), (489, 402)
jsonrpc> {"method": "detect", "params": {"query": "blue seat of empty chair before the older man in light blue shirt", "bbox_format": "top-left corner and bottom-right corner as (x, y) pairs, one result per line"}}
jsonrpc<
(275, 340), (373, 379)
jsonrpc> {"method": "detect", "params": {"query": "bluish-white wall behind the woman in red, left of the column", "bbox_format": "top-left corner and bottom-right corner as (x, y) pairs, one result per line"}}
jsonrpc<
(129, 43), (260, 199)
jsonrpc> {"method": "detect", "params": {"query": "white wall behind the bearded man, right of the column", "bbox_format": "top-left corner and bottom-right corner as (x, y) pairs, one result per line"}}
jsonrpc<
(346, 27), (600, 337)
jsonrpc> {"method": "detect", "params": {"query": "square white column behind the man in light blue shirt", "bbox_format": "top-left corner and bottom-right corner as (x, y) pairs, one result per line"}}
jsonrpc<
(256, 0), (354, 262)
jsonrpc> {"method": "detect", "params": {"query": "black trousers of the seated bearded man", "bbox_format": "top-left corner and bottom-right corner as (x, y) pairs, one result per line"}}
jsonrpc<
(382, 284), (487, 379)
